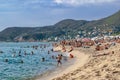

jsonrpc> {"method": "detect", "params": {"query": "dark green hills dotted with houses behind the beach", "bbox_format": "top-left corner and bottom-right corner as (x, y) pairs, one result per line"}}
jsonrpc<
(0, 11), (120, 41)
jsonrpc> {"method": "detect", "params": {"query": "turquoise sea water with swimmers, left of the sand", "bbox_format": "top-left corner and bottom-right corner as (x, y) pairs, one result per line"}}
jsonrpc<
(0, 42), (58, 80)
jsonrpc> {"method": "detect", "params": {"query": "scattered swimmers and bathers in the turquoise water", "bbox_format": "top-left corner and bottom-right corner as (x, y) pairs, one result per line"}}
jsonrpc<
(1, 44), (67, 66)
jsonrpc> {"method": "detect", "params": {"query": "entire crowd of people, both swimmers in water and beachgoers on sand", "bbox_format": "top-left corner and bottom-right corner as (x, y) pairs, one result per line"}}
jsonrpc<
(1, 37), (120, 66)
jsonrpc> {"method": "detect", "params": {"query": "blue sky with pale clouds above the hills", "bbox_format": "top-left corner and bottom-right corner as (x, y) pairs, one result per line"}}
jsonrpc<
(0, 0), (120, 31)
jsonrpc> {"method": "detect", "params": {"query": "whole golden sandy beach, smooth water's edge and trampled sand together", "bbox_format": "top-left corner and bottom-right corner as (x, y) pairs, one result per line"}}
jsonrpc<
(36, 38), (120, 80)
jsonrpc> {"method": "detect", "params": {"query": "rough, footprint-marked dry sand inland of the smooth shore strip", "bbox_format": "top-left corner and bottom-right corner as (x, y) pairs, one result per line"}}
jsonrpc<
(52, 44), (120, 80)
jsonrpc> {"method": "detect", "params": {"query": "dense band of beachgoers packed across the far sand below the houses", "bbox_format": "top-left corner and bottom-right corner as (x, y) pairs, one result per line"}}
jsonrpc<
(56, 37), (120, 51)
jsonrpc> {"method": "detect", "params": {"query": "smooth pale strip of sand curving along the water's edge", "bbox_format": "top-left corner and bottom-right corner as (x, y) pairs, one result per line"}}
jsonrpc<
(34, 46), (89, 80)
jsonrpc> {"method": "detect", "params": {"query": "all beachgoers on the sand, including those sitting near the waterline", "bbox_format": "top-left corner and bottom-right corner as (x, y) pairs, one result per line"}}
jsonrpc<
(54, 37), (120, 57)
